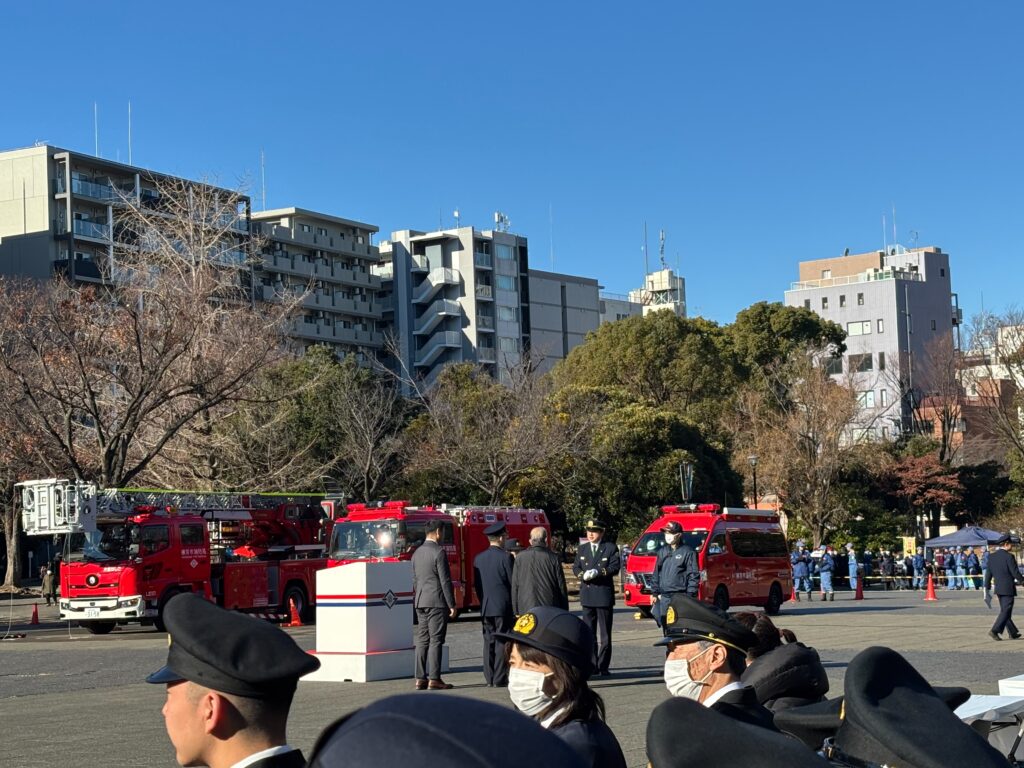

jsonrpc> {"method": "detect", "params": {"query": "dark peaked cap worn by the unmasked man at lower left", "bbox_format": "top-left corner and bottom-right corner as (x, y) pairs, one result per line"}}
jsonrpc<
(145, 592), (319, 698)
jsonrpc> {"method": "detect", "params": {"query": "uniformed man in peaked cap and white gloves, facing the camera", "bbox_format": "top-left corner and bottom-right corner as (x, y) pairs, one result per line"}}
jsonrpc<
(572, 520), (620, 677)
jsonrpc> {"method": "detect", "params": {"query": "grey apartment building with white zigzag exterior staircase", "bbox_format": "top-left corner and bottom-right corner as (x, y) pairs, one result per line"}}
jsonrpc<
(377, 226), (530, 385)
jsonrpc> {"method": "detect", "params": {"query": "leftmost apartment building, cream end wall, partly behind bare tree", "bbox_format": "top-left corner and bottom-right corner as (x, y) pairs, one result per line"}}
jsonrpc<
(0, 144), (250, 283)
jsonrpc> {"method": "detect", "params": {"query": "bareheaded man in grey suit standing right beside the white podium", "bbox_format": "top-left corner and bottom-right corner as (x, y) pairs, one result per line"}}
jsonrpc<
(413, 520), (459, 690)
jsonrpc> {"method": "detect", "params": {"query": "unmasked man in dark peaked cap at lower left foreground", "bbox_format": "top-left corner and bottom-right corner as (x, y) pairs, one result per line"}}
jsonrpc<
(146, 593), (319, 768)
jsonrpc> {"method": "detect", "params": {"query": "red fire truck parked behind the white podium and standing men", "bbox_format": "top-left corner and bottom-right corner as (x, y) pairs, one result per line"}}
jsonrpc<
(328, 501), (551, 609)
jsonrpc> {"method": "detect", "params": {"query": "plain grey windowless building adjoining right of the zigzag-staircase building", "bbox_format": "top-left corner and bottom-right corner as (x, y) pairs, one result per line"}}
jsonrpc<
(529, 269), (601, 371)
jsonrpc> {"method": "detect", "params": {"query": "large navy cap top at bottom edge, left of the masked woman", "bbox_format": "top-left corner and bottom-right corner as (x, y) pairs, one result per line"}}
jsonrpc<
(309, 693), (583, 768)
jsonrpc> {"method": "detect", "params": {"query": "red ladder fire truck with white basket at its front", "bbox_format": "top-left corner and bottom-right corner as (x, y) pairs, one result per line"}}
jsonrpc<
(17, 479), (334, 634)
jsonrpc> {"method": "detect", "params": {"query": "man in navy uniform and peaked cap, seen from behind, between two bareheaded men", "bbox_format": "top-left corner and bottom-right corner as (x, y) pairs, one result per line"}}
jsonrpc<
(473, 522), (514, 688)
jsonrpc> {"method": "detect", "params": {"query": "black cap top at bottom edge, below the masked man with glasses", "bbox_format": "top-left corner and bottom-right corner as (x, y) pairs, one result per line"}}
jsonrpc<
(647, 696), (828, 768)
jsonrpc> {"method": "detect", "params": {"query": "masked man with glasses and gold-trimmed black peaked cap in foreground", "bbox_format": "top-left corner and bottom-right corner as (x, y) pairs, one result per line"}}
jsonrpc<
(654, 594), (775, 730)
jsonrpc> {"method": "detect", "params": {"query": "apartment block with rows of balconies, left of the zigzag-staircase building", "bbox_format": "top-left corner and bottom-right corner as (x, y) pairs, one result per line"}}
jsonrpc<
(252, 208), (384, 362)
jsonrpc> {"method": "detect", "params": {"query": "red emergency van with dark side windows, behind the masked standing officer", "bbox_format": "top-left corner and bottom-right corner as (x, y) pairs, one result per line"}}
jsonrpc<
(626, 504), (793, 616)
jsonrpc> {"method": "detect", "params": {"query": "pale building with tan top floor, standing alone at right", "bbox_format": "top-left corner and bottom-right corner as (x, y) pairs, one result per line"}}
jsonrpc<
(785, 246), (963, 439)
